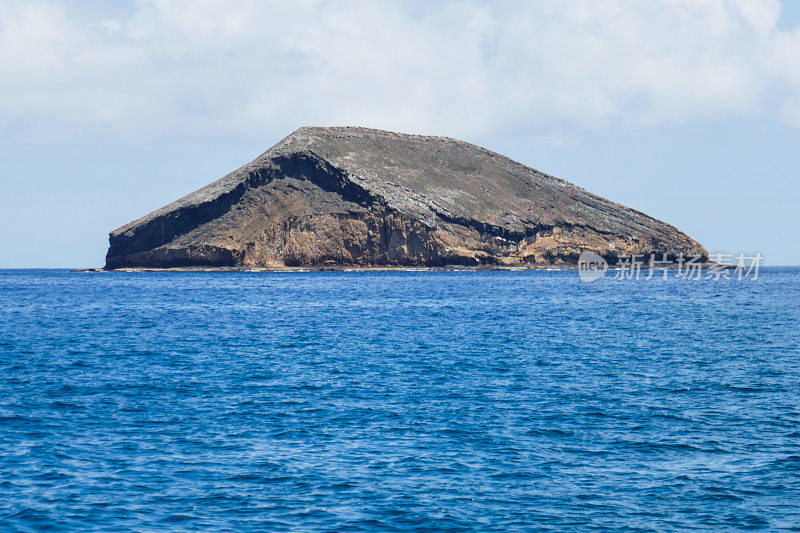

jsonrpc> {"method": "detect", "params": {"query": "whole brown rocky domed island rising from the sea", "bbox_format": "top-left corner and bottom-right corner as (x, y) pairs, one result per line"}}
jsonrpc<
(106, 127), (708, 269)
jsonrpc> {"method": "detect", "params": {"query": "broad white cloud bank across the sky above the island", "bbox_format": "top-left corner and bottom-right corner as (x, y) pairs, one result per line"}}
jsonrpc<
(0, 0), (800, 138)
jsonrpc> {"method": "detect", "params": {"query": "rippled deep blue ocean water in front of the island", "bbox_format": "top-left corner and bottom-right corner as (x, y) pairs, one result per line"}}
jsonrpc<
(0, 268), (800, 532)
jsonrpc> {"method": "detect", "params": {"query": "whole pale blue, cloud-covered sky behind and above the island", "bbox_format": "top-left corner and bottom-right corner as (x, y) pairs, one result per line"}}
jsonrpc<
(0, 0), (800, 268)
